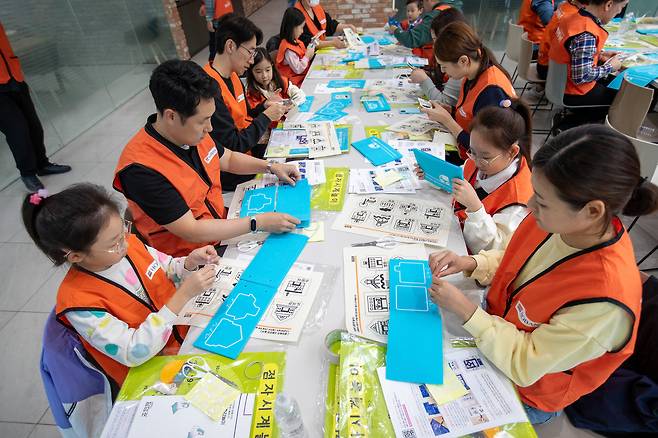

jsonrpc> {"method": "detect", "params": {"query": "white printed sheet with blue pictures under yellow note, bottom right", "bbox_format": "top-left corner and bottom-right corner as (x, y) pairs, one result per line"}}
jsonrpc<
(377, 348), (528, 438)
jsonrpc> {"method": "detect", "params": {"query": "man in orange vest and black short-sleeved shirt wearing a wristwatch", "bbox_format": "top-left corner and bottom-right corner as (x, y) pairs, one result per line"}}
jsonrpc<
(113, 60), (300, 256)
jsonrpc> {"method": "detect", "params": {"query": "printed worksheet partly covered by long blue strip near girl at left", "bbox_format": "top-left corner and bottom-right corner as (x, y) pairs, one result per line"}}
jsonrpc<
(175, 258), (323, 342)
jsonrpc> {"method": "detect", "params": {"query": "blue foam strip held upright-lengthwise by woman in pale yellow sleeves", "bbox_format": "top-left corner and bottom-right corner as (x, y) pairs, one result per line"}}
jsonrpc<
(386, 259), (443, 384)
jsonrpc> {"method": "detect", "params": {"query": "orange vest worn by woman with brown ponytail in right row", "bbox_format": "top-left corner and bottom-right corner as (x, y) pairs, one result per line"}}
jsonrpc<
(455, 65), (516, 159)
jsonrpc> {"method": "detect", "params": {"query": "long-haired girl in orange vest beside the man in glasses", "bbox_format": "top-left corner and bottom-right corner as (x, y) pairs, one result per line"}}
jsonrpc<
(247, 47), (306, 116)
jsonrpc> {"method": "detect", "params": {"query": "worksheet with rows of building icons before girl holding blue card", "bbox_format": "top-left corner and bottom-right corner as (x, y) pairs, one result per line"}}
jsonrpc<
(332, 195), (453, 246)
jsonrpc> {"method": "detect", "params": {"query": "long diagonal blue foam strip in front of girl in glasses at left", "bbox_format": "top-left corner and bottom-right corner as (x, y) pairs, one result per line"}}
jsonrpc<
(194, 233), (308, 359)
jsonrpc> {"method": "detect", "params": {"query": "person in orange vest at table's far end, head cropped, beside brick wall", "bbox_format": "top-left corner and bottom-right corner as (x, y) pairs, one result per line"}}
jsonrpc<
(295, 0), (356, 49)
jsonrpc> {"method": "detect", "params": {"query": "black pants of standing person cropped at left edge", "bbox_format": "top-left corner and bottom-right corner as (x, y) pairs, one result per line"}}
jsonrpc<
(0, 82), (48, 176)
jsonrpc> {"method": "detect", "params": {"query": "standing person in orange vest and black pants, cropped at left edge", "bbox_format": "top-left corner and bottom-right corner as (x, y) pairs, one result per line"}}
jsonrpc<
(0, 23), (71, 192)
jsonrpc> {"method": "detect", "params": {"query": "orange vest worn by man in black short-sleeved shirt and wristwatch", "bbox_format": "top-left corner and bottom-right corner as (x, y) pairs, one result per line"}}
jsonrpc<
(113, 128), (226, 257)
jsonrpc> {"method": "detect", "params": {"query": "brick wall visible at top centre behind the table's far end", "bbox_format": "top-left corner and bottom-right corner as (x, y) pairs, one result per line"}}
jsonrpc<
(322, 0), (391, 29)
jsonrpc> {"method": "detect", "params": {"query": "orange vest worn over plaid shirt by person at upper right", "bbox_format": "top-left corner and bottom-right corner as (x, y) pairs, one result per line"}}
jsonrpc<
(548, 10), (608, 96)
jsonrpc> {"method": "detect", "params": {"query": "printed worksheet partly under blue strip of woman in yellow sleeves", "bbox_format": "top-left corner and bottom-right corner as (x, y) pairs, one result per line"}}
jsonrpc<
(343, 244), (427, 343)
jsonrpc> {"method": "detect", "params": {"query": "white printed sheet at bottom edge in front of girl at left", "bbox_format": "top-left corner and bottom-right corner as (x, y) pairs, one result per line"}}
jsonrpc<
(128, 394), (256, 438)
